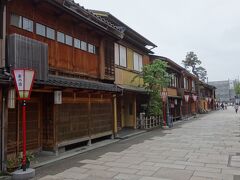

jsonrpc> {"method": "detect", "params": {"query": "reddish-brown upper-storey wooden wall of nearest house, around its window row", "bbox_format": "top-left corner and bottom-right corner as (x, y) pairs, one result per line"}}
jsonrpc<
(7, 0), (114, 79)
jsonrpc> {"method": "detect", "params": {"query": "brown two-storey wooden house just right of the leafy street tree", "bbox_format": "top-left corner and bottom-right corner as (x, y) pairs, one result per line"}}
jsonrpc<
(151, 55), (202, 121)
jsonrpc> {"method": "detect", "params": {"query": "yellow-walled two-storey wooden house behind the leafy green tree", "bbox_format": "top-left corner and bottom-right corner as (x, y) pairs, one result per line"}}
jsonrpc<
(92, 11), (156, 130)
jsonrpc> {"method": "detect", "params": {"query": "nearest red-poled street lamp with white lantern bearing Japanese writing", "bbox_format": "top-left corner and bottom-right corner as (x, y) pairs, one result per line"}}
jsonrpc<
(13, 69), (35, 171)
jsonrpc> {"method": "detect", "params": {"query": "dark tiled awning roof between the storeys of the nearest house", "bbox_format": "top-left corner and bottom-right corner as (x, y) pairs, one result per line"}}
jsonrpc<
(36, 76), (120, 92)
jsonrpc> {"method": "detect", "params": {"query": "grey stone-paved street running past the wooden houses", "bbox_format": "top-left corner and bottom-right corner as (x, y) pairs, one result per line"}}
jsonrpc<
(37, 107), (240, 180)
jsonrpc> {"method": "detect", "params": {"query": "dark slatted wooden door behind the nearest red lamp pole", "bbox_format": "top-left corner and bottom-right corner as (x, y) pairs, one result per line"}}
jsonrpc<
(8, 97), (41, 154)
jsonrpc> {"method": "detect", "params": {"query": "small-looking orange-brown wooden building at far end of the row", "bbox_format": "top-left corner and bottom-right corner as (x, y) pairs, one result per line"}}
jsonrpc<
(199, 81), (216, 113)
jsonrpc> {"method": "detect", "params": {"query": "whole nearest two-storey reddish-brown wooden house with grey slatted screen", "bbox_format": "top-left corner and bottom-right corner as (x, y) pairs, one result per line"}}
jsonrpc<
(6, 0), (124, 157)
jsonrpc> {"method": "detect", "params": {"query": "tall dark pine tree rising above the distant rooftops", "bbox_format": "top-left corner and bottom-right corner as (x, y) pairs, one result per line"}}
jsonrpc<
(182, 51), (207, 81)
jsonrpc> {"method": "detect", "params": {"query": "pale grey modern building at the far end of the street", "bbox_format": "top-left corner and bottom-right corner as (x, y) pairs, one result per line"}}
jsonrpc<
(209, 80), (235, 102)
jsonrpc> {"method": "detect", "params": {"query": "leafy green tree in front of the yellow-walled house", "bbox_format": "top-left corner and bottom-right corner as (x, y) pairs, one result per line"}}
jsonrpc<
(134, 59), (169, 116)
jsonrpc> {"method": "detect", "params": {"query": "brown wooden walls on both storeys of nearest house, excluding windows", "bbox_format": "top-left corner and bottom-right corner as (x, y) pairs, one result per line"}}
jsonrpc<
(7, 0), (122, 154)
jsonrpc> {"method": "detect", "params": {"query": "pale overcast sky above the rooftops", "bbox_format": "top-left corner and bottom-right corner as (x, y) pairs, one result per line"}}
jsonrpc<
(75, 0), (240, 81)
